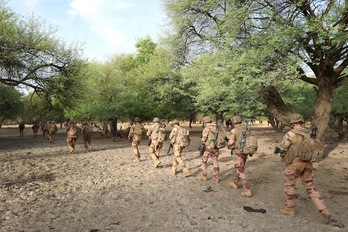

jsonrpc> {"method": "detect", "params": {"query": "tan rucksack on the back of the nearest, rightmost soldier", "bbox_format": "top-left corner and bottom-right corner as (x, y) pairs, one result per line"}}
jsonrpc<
(291, 127), (323, 162)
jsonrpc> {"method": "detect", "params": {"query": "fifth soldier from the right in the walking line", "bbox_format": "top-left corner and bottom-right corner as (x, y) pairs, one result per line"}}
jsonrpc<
(146, 117), (165, 168)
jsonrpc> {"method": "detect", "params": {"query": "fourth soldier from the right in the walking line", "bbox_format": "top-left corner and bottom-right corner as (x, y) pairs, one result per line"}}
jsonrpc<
(169, 120), (191, 177)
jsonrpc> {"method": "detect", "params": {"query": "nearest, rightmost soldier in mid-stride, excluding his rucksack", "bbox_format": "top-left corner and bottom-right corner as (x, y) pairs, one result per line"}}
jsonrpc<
(279, 114), (331, 224)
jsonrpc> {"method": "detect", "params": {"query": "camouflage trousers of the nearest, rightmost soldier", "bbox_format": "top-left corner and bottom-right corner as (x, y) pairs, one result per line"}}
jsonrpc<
(284, 158), (326, 211)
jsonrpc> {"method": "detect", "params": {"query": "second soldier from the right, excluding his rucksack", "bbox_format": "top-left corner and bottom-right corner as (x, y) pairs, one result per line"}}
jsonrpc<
(227, 116), (252, 197)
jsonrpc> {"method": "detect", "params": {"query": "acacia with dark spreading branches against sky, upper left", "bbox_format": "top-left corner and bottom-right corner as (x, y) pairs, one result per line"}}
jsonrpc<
(0, 0), (84, 102)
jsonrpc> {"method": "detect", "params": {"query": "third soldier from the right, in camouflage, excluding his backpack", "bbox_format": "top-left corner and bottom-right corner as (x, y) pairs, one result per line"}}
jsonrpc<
(198, 117), (220, 183)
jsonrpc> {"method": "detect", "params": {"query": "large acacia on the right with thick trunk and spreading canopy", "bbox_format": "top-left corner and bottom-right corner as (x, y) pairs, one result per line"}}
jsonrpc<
(164, 0), (348, 138)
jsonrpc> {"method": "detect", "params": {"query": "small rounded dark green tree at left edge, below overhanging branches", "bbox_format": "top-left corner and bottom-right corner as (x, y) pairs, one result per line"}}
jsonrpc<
(0, 84), (24, 127)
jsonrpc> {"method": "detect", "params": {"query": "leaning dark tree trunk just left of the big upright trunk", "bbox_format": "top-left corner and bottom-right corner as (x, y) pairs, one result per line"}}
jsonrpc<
(259, 86), (292, 130)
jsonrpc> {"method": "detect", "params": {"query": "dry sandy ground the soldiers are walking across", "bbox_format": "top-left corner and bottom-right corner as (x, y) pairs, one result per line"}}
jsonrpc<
(0, 125), (348, 232)
